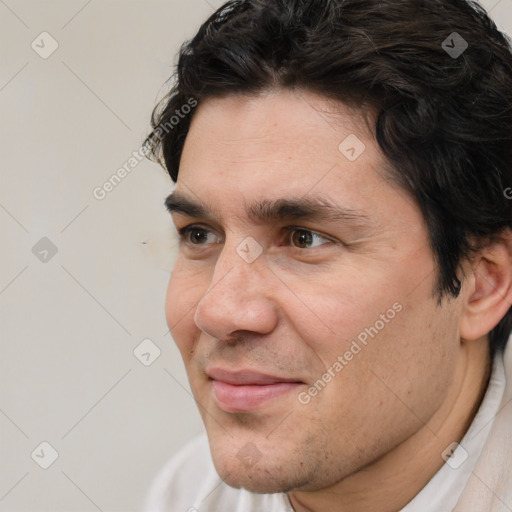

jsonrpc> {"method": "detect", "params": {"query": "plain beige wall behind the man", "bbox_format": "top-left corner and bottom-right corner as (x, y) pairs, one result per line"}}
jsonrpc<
(0, 0), (512, 512)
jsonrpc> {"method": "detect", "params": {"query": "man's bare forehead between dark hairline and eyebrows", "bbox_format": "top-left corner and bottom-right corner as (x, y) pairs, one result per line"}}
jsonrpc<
(176, 90), (414, 227)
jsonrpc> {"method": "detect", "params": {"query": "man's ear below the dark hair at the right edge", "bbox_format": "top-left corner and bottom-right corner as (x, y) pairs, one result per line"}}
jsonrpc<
(460, 228), (512, 340)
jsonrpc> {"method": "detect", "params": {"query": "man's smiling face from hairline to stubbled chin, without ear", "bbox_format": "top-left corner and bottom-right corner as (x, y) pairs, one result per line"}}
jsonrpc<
(166, 91), (460, 492)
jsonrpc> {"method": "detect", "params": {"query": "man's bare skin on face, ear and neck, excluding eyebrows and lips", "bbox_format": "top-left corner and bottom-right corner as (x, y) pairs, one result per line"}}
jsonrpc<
(166, 90), (512, 512)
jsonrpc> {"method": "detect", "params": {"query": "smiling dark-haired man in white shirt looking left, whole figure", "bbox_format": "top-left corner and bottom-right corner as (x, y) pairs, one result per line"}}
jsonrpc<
(142, 0), (512, 512)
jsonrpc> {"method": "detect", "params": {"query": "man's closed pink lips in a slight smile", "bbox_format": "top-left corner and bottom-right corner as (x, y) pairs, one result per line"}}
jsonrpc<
(207, 368), (304, 412)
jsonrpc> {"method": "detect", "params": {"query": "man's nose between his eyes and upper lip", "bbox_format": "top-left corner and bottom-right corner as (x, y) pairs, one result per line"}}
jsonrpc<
(194, 245), (278, 340)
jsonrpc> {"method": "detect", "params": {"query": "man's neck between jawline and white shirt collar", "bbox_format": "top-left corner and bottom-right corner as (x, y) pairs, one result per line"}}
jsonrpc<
(289, 338), (491, 512)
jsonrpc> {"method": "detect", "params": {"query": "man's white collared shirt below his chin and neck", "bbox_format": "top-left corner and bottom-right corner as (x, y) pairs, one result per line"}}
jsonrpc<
(144, 352), (506, 512)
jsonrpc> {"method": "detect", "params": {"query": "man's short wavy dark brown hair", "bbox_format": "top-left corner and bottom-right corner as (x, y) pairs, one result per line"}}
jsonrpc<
(146, 0), (512, 350)
